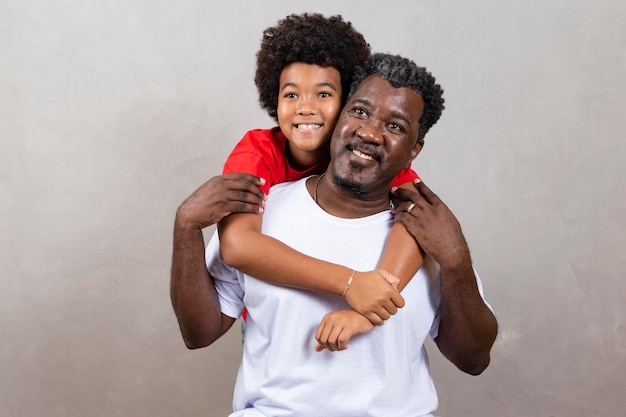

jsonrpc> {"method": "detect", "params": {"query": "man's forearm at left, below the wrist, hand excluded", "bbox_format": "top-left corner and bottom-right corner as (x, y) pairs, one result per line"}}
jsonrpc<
(170, 221), (232, 349)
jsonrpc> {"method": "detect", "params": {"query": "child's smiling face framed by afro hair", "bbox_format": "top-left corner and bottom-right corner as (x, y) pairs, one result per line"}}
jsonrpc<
(277, 62), (342, 169)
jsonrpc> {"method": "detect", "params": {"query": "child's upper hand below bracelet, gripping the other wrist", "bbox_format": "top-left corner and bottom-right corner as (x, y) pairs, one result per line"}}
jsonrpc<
(345, 270), (404, 326)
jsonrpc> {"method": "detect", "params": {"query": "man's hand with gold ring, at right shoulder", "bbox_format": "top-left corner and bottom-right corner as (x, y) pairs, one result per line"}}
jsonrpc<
(393, 182), (469, 266)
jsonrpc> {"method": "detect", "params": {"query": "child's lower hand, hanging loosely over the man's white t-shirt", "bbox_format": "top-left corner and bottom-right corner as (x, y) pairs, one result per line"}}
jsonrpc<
(315, 310), (374, 352)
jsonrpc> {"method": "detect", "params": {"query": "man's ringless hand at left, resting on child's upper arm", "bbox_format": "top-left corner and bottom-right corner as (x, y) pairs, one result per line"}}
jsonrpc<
(176, 173), (266, 229)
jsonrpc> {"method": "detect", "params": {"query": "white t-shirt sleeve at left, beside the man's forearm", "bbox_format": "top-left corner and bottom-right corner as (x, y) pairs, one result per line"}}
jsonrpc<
(205, 232), (244, 319)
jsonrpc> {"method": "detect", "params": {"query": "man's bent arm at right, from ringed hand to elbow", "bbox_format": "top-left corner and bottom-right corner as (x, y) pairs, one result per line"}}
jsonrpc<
(394, 182), (498, 375)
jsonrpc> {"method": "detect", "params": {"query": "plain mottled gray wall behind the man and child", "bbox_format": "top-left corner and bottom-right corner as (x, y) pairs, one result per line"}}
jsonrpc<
(0, 0), (626, 417)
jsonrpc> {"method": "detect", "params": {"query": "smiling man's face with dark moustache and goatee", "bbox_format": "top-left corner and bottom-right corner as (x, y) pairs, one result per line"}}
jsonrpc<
(331, 76), (424, 191)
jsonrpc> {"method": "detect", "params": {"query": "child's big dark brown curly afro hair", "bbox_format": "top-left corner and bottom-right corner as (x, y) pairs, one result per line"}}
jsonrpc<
(254, 13), (371, 120)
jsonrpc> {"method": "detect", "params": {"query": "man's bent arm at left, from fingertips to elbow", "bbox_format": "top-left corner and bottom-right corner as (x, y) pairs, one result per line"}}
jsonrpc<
(170, 174), (264, 349)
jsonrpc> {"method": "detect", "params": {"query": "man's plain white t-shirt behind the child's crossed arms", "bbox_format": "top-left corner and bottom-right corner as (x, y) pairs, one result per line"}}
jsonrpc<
(207, 179), (448, 417)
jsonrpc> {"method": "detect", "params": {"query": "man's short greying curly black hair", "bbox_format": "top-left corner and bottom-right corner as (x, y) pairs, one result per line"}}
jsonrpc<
(348, 53), (445, 142)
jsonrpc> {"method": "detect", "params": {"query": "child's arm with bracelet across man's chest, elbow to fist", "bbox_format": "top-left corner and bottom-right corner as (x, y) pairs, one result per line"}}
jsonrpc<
(218, 213), (404, 325)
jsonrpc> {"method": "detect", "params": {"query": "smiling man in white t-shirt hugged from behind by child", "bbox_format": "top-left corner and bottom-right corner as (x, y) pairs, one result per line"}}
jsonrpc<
(172, 54), (497, 417)
